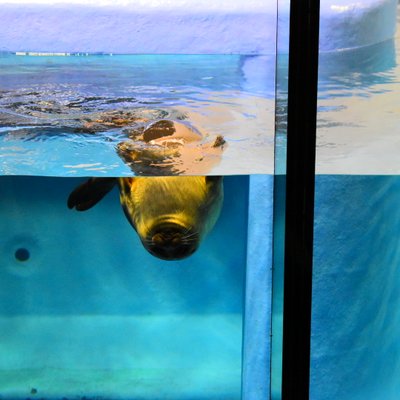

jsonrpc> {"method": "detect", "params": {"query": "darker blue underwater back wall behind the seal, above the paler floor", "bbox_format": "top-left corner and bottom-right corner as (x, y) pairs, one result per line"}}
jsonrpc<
(0, 177), (248, 315)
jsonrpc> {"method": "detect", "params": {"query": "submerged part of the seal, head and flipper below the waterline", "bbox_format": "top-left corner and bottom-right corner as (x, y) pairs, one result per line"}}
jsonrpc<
(68, 176), (223, 260)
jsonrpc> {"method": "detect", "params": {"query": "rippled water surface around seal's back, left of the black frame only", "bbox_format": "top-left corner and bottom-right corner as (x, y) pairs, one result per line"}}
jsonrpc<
(0, 53), (275, 176)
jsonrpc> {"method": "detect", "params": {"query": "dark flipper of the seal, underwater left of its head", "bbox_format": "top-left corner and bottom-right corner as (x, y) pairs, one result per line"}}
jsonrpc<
(67, 178), (117, 211)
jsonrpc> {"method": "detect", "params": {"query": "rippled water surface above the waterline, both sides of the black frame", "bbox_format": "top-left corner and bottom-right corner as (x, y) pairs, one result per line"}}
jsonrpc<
(0, 3), (400, 176)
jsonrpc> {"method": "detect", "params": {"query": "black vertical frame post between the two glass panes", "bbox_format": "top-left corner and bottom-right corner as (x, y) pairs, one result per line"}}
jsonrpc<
(282, 0), (319, 400)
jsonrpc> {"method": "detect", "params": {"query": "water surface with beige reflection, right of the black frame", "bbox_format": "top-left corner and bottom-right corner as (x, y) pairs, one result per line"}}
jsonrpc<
(316, 10), (400, 174)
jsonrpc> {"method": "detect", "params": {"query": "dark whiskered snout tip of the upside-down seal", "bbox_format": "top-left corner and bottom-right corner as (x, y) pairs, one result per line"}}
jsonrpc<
(144, 222), (199, 260)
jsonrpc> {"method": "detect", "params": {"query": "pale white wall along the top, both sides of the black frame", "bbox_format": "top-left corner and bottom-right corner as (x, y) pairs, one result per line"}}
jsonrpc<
(0, 0), (397, 54)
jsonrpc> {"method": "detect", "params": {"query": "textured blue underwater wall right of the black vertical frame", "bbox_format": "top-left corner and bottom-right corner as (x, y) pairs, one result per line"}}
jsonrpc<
(311, 175), (400, 400)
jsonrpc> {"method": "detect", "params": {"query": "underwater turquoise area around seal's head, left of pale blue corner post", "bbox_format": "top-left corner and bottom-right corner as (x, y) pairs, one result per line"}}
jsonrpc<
(0, 177), (249, 400)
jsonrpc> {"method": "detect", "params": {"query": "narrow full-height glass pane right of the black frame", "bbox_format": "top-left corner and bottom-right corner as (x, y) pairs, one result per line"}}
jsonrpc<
(310, 0), (400, 400)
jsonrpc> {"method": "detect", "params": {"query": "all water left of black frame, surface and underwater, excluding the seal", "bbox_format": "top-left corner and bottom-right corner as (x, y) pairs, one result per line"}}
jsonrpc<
(0, 50), (275, 400)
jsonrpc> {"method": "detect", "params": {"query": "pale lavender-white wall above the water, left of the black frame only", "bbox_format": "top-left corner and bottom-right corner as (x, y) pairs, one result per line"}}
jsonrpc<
(0, 0), (276, 54)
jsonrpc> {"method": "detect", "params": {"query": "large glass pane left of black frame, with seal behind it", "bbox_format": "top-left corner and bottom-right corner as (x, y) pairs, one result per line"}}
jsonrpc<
(0, 0), (278, 400)
